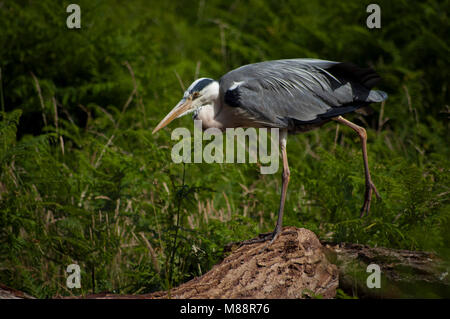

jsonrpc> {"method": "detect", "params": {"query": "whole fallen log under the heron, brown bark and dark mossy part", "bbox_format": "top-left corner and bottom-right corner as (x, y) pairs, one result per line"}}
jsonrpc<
(0, 227), (450, 299)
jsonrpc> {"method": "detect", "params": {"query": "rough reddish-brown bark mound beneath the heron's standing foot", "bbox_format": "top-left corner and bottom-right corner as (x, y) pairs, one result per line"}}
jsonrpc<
(148, 227), (338, 299)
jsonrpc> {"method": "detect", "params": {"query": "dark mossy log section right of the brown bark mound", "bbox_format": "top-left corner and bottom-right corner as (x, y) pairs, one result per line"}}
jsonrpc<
(322, 242), (450, 298)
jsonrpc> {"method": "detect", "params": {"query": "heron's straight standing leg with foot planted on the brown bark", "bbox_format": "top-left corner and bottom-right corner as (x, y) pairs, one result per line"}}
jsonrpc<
(241, 130), (290, 250)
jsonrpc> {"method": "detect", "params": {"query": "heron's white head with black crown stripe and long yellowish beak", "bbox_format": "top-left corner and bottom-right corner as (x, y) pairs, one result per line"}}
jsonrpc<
(152, 78), (219, 134)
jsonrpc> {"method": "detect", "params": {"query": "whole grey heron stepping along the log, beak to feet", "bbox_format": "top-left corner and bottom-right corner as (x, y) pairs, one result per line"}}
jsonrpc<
(153, 59), (387, 243)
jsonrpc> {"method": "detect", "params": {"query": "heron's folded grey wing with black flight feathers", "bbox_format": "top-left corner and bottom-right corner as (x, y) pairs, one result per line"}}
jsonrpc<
(220, 59), (387, 128)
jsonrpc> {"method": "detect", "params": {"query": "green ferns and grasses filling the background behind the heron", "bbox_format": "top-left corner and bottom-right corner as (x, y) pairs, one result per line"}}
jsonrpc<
(0, 0), (450, 297)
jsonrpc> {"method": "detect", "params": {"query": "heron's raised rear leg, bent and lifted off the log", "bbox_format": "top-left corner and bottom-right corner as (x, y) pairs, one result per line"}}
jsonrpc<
(333, 116), (381, 217)
